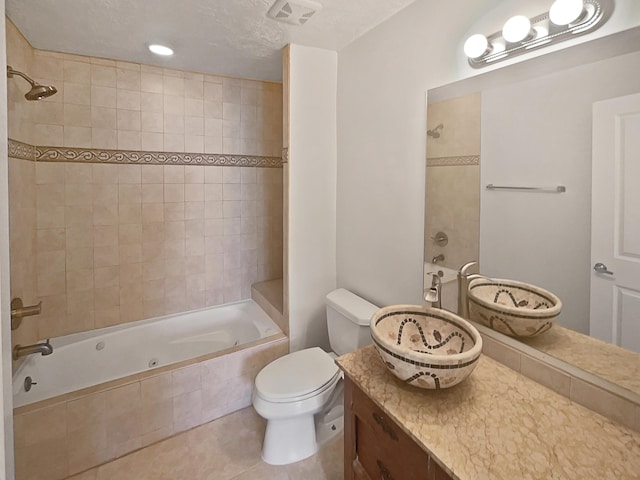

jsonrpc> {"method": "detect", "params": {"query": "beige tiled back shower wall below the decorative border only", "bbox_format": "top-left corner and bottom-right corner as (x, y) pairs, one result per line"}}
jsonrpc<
(28, 162), (282, 344)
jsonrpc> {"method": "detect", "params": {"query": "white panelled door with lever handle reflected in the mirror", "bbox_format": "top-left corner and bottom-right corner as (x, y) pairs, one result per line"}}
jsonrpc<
(590, 94), (640, 352)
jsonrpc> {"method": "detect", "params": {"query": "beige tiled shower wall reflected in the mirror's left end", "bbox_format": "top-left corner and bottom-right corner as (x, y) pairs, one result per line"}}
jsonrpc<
(425, 94), (480, 270)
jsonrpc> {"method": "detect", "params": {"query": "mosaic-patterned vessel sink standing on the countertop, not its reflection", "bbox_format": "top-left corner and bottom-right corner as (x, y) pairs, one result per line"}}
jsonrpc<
(371, 305), (482, 389)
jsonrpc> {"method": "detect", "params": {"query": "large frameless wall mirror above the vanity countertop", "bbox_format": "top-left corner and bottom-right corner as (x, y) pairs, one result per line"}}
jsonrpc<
(425, 28), (640, 403)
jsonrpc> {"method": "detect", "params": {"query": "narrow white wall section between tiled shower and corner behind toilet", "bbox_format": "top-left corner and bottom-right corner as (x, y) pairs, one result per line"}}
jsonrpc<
(289, 45), (338, 351)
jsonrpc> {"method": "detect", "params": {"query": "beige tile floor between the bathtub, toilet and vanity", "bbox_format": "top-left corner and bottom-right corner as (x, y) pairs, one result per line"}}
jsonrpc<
(68, 407), (344, 480)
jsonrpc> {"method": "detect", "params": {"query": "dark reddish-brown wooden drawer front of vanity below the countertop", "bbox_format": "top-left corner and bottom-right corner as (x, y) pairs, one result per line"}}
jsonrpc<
(352, 388), (429, 480)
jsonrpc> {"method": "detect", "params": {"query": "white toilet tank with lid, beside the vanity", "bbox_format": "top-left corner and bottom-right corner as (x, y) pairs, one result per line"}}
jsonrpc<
(325, 288), (378, 355)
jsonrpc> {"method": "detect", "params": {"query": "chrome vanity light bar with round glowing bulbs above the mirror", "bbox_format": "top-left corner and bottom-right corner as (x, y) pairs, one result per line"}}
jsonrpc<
(464, 0), (614, 68)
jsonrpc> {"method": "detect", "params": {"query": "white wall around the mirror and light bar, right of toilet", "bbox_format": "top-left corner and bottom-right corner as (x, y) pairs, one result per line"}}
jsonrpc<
(337, 0), (640, 305)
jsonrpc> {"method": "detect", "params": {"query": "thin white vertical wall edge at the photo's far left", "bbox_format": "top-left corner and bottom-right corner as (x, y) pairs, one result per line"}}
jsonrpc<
(0, 0), (14, 480)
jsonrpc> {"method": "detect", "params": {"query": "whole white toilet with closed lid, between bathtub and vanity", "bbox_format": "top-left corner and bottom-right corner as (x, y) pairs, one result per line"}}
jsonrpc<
(252, 288), (378, 465)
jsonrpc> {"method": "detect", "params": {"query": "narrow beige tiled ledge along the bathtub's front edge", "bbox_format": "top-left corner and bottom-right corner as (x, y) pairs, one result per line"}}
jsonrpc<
(13, 327), (289, 416)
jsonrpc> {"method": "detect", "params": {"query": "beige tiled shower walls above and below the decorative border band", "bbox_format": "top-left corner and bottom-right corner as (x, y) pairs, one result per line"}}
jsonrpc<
(7, 20), (282, 343)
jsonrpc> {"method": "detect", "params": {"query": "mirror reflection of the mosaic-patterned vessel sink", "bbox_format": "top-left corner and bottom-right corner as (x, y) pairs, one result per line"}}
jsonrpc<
(468, 278), (562, 337)
